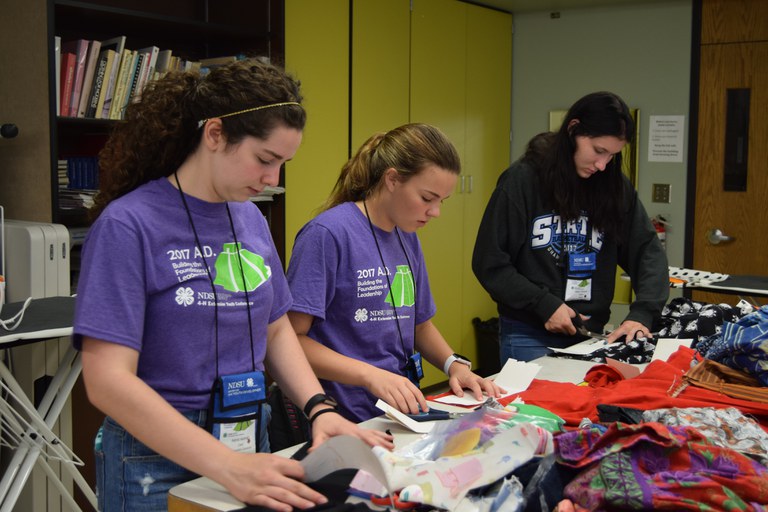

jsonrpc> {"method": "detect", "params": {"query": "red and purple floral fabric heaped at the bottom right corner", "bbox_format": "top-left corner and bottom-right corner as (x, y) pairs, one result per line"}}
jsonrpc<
(555, 423), (768, 511)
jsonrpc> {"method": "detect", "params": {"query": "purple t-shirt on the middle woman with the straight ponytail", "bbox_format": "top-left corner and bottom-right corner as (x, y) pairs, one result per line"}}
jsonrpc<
(288, 203), (435, 422)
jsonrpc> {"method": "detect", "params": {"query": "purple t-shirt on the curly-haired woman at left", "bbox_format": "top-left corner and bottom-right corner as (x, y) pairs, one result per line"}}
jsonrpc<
(73, 178), (291, 411)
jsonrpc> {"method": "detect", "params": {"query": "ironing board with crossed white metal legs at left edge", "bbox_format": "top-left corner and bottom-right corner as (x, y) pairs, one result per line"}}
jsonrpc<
(0, 297), (96, 512)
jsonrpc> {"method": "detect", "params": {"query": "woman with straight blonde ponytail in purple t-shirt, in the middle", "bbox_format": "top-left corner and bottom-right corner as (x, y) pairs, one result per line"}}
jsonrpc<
(288, 124), (499, 421)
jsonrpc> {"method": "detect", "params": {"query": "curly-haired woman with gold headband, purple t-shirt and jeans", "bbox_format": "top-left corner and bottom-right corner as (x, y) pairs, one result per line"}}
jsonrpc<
(74, 60), (392, 512)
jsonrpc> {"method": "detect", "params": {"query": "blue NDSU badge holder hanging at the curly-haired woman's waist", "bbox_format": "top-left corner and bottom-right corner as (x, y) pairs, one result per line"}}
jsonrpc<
(208, 371), (267, 453)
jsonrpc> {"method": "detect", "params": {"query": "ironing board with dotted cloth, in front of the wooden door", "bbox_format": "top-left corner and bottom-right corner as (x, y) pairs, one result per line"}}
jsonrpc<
(669, 267), (768, 297)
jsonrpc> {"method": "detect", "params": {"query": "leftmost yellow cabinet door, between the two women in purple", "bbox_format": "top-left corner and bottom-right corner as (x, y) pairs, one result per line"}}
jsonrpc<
(285, 0), (349, 261)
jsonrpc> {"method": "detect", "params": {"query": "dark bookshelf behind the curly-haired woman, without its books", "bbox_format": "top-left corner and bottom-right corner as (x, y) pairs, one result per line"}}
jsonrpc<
(48, 0), (284, 232)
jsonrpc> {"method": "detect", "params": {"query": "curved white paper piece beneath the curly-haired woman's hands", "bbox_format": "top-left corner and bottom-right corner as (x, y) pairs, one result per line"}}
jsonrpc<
(300, 435), (389, 487)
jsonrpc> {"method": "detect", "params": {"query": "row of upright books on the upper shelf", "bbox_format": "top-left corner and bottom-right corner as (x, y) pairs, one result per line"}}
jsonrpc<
(55, 36), (232, 119)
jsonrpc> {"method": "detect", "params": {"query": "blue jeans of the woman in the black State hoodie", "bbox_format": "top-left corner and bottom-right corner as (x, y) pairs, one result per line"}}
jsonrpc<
(499, 317), (579, 367)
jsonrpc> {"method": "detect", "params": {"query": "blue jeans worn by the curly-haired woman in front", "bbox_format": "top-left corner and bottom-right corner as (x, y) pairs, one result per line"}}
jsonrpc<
(94, 404), (271, 512)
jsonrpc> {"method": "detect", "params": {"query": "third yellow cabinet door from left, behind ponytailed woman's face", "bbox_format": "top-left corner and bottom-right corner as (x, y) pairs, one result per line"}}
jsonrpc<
(410, 0), (467, 387)
